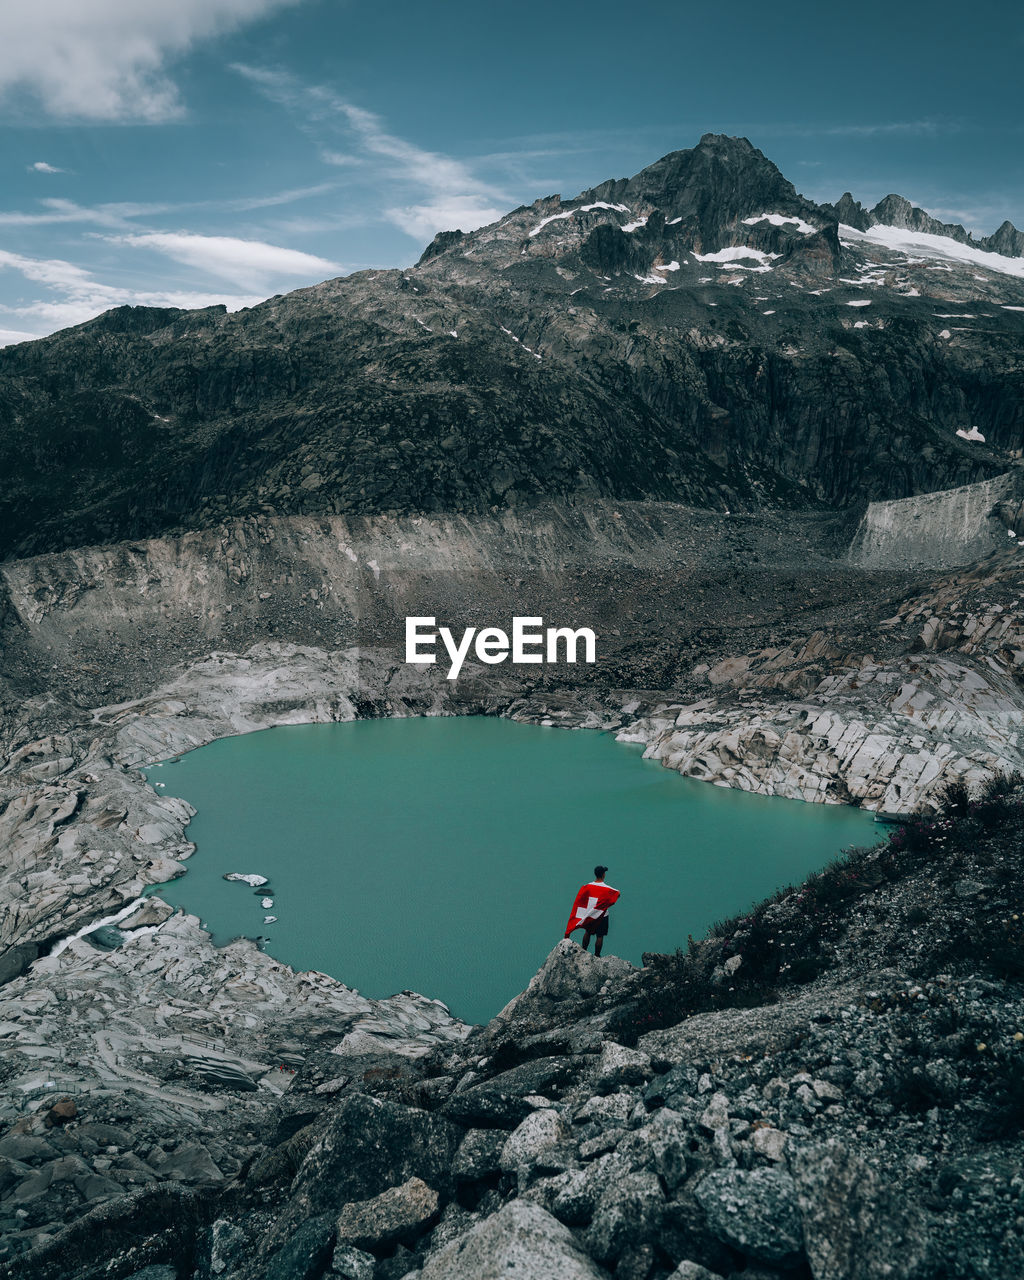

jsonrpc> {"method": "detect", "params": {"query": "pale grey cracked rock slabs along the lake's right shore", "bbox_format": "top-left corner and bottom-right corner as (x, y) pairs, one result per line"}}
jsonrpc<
(617, 620), (1024, 813)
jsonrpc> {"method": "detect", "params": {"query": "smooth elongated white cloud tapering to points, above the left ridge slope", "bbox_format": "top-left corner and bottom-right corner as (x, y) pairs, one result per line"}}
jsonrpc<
(105, 232), (340, 289)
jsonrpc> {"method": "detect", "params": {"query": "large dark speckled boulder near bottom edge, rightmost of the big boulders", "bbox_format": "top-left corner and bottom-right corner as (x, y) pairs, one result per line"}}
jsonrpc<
(695, 1169), (820, 1264)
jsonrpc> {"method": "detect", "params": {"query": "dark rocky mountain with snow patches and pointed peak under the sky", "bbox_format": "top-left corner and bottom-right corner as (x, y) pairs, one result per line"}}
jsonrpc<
(0, 136), (1024, 556)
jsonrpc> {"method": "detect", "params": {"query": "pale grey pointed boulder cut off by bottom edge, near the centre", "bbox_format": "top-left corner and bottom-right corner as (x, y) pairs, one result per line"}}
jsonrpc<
(420, 1199), (603, 1280)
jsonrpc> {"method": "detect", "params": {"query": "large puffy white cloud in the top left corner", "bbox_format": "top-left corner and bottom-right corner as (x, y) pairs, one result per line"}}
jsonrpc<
(0, 0), (297, 122)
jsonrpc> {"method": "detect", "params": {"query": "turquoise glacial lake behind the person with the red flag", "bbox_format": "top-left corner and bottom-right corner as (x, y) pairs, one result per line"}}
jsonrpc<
(146, 716), (879, 1021)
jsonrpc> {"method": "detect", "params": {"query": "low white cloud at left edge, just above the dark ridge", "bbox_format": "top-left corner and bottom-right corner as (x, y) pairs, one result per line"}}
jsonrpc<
(0, 250), (264, 346)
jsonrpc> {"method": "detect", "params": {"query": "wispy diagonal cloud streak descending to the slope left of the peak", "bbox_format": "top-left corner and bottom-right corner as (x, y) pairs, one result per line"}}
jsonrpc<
(233, 64), (512, 241)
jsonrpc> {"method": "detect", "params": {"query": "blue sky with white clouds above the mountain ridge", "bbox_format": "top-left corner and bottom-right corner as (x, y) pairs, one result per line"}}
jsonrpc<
(0, 0), (1024, 344)
